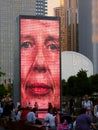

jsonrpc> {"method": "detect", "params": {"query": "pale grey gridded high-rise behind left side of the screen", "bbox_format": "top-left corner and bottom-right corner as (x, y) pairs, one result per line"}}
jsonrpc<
(0, 0), (47, 83)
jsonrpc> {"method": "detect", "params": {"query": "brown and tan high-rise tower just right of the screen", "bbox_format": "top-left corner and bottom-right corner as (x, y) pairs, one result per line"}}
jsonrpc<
(55, 0), (78, 51)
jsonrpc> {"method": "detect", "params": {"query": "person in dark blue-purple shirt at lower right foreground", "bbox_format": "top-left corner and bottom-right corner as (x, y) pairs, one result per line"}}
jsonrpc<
(75, 108), (94, 130)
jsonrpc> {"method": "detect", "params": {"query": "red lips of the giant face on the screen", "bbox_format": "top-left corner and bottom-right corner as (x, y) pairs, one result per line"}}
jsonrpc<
(26, 83), (53, 96)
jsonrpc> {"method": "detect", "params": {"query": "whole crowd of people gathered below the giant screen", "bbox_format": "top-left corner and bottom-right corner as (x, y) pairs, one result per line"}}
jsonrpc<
(0, 95), (98, 130)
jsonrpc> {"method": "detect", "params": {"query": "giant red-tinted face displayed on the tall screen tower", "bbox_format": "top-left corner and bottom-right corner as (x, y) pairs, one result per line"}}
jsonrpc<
(20, 18), (60, 108)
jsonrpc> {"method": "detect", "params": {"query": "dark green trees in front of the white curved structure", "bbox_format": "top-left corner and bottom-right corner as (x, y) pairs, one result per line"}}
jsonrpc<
(62, 70), (98, 97)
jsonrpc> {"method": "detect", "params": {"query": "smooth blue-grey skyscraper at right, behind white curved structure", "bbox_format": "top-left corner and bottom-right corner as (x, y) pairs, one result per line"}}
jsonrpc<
(79, 0), (98, 74)
